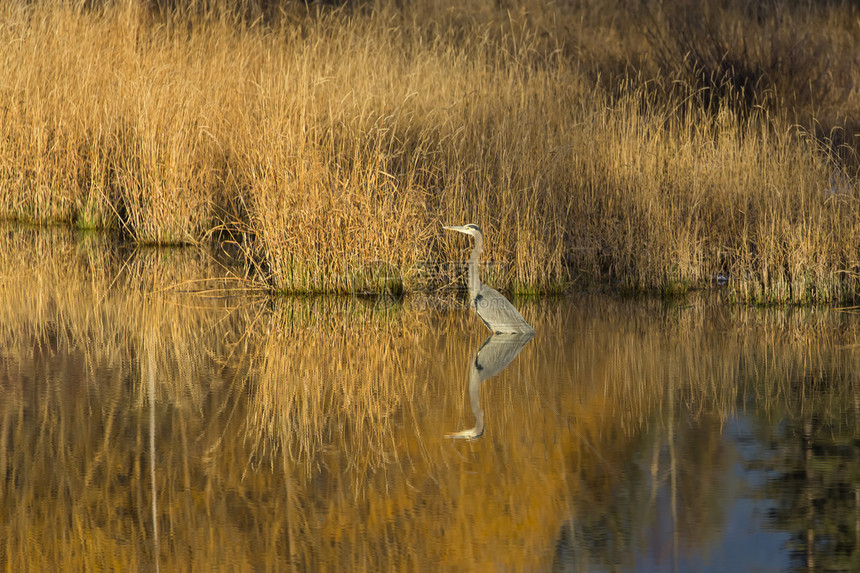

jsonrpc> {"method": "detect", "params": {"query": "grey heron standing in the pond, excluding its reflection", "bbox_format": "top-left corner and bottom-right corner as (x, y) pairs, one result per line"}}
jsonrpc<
(445, 223), (534, 334)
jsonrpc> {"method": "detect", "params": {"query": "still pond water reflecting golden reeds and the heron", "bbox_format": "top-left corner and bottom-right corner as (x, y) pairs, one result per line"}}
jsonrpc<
(0, 229), (860, 571)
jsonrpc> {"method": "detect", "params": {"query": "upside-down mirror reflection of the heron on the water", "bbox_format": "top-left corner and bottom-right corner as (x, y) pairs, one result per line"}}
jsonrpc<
(445, 332), (534, 440)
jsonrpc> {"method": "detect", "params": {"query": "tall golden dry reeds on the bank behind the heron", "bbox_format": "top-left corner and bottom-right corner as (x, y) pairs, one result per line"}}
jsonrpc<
(0, 0), (860, 302)
